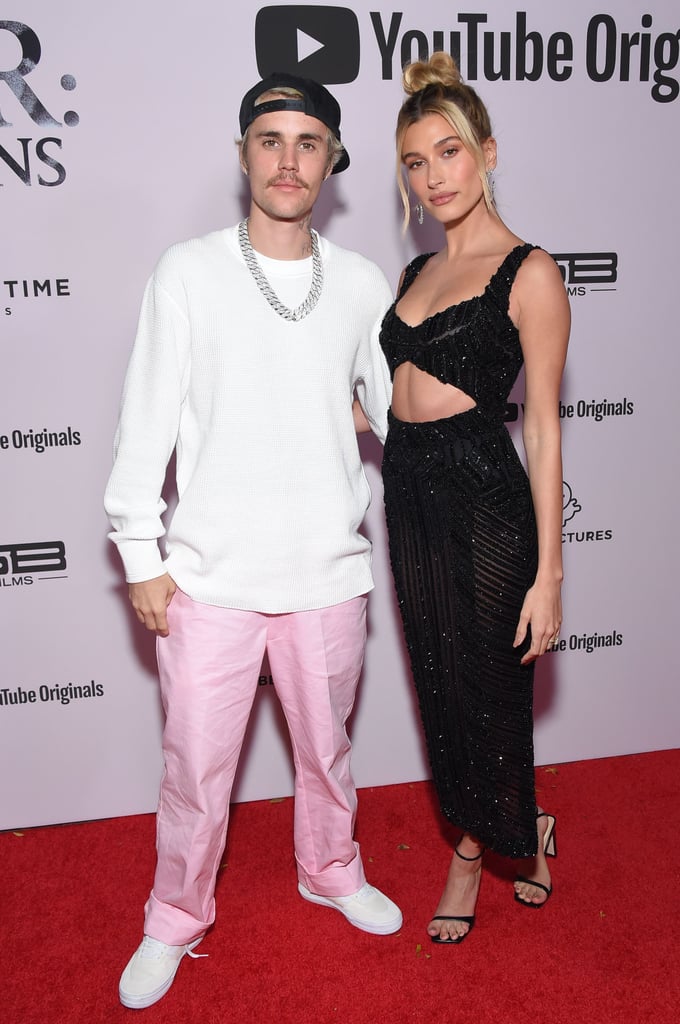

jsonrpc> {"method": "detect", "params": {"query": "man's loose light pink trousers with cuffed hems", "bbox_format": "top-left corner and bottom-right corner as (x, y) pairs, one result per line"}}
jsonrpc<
(144, 590), (367, 945)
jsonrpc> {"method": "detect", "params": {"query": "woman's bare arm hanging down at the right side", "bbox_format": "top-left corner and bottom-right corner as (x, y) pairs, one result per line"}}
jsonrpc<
(511, 250), (570, 664)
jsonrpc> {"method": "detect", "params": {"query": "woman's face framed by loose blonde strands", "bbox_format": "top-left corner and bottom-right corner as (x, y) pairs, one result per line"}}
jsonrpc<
(401, 114), (496, 223)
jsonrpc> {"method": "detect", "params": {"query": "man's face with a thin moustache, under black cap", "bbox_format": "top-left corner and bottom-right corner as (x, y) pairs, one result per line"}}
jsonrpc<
(241, 111), (331, 221)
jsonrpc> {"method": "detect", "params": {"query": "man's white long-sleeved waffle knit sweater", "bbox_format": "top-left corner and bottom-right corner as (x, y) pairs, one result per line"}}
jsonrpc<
(104, 227), (392, 613)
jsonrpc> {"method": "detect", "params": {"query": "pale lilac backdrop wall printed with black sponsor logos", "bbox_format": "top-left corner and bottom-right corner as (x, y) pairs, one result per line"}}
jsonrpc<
(0, 0), (680, 828)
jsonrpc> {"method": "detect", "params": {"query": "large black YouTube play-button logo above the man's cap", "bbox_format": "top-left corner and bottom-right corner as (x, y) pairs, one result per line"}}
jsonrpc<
(255, 4), (360, 85)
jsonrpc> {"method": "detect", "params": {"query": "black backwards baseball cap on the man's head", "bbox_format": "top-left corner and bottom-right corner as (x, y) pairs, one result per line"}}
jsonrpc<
(239, 72), (349, 174)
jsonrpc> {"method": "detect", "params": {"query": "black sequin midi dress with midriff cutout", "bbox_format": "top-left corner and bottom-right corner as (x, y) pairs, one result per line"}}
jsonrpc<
(381, 245), (538, 857)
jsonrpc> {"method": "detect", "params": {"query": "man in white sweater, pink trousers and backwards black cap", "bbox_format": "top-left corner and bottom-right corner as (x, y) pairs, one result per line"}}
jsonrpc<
(105, 74), (401, 1009)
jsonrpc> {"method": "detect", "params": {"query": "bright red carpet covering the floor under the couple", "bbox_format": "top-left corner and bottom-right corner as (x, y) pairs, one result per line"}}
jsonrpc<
(5, 751), (680, 1024)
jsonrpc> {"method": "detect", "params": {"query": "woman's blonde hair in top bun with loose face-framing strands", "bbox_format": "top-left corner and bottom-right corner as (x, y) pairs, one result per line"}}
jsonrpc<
(396, 50), (495, 228)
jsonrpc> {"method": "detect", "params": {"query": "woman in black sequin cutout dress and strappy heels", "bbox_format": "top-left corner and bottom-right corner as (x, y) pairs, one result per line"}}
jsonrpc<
(381, 53), (569, 944)
